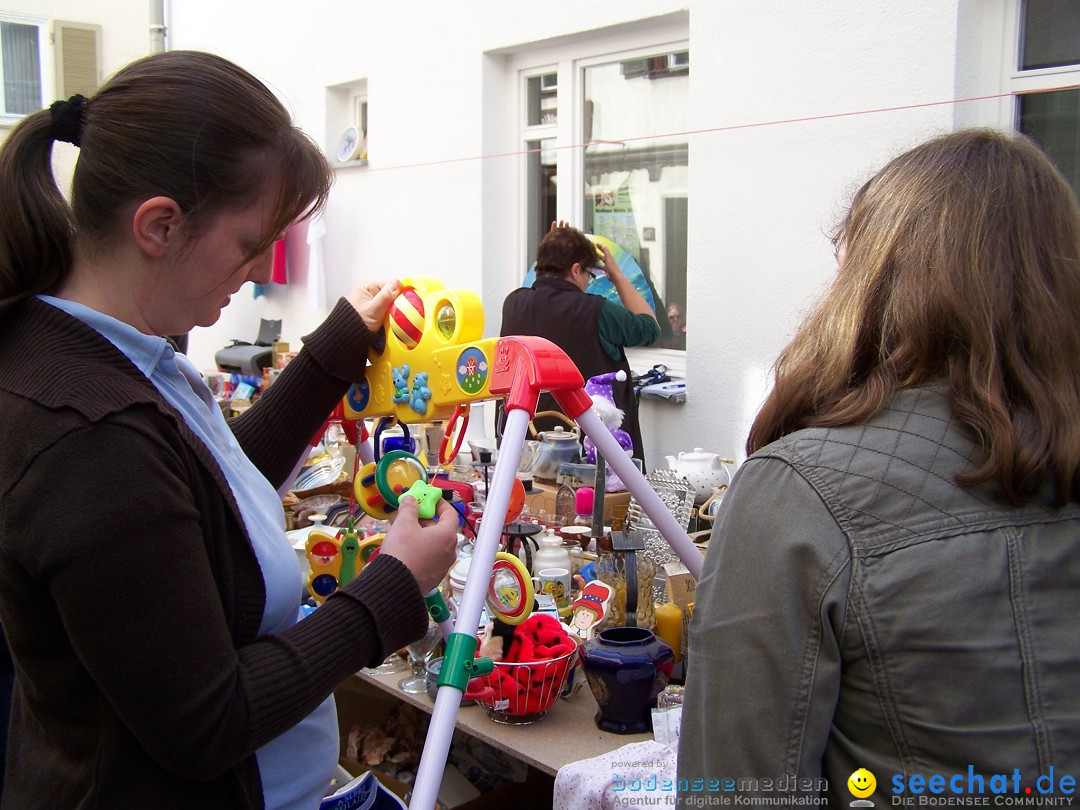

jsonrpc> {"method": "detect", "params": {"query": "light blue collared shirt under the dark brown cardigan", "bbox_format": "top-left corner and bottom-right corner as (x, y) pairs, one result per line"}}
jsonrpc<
(38, 295), (339, 810)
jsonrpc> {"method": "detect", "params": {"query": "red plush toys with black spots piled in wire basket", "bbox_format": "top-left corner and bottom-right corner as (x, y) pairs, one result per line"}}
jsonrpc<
(484, 613), (578, 715)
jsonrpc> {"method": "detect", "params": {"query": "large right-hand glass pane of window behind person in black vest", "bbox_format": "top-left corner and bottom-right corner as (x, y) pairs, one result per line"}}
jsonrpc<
(582, 51), (690, 349)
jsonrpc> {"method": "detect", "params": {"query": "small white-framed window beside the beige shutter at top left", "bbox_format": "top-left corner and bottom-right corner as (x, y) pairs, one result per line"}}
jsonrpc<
(0, 13), (48, 123)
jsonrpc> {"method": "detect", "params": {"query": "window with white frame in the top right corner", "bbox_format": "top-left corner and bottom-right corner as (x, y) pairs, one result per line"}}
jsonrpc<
(1005, 0), (1080, 195)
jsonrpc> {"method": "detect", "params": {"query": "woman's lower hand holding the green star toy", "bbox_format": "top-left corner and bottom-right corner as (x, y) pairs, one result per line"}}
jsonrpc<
(379, 496), (458, 594)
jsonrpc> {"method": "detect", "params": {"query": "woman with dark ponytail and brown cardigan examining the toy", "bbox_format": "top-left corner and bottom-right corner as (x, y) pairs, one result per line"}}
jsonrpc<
(0, 51), (457, 810)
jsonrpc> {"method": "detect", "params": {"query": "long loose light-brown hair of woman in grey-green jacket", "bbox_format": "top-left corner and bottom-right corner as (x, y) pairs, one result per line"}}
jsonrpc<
(746, 130), (1080, 503)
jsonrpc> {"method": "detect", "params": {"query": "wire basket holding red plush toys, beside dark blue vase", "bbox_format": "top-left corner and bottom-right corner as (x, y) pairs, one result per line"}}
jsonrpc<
(476, 648), (578, 725)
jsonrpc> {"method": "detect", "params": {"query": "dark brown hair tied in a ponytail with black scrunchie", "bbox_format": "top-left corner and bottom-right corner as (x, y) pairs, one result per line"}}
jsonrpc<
(0, 51), (333, 311)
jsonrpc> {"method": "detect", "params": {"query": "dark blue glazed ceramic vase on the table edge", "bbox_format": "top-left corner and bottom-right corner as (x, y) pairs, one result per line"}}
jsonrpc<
(581, 627), (675, 734)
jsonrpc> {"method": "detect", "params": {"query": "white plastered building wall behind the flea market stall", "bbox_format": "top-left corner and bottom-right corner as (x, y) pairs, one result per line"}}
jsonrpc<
(10, 0), (986, 468)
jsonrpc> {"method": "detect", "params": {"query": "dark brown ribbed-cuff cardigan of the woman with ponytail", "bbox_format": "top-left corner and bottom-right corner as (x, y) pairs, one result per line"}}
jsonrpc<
(0, 300), (427, 810)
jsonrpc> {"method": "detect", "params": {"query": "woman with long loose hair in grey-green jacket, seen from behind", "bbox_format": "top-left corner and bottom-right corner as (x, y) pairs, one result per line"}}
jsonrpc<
(678, 131), (1080, 808)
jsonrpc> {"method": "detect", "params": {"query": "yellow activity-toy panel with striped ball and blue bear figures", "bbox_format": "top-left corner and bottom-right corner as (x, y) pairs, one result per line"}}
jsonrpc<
(345, 276), (498, 423)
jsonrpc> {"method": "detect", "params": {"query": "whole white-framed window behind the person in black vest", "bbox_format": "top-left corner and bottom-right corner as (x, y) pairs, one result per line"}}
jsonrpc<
(519, 23), (693, 373)
